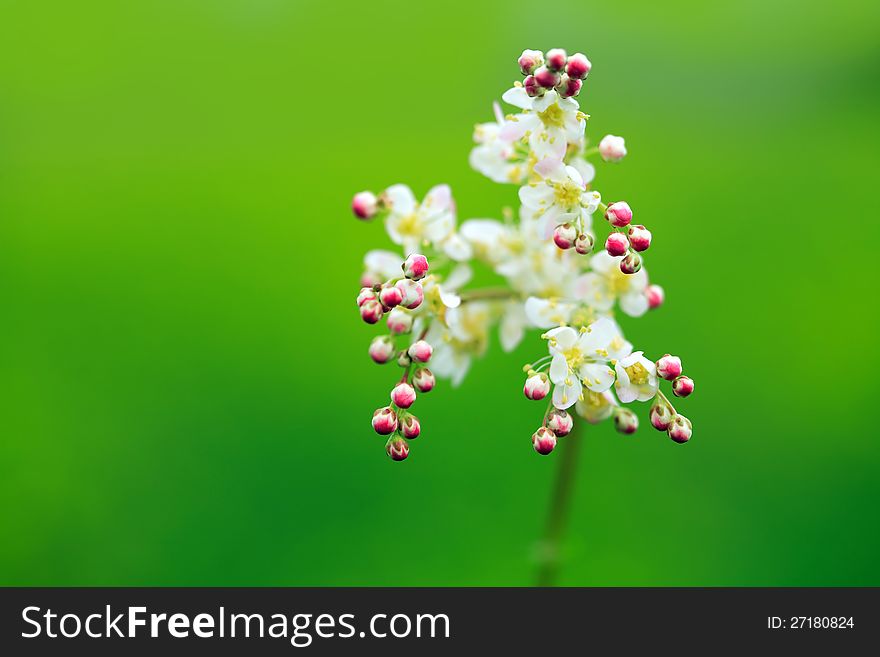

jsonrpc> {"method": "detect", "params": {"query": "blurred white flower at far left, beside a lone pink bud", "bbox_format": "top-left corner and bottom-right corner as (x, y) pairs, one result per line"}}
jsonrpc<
(385, 185), (455, 255)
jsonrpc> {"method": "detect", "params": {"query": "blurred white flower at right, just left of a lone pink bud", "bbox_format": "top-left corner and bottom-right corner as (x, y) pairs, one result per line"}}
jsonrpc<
(574, 251), (648, 317)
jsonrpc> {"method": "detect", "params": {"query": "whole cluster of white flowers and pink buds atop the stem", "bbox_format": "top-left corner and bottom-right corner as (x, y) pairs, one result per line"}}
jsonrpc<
(352, 48), (694, 460)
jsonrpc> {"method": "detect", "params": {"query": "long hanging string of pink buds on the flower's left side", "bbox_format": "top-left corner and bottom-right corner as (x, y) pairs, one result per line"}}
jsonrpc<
(357, 253), (435, 461)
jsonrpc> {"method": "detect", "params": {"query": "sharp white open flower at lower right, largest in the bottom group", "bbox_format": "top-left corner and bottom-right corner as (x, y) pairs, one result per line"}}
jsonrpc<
(544, 317), (617, 409)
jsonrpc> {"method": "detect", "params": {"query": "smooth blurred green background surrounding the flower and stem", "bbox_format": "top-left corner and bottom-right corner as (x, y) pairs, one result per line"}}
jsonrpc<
(0, 0), (880, 585)
